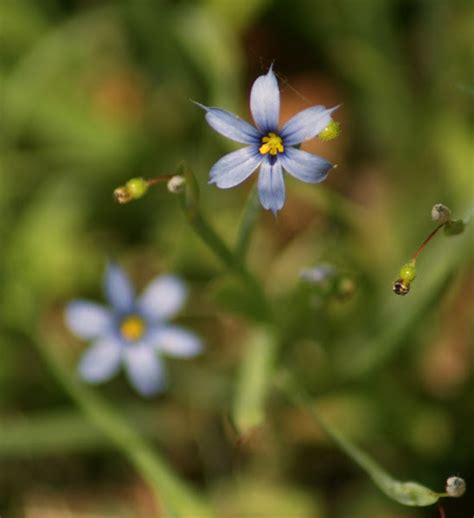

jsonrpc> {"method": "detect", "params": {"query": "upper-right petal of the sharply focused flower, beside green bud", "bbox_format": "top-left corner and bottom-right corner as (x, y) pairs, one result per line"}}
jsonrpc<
(280, 106), (338, 146)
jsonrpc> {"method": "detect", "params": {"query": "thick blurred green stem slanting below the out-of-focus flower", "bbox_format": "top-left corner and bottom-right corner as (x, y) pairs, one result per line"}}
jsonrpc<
(35, 342), (214, 518)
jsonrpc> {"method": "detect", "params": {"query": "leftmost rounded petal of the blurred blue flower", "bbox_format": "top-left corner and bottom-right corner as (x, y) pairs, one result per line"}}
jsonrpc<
(64, 300), (112, 340)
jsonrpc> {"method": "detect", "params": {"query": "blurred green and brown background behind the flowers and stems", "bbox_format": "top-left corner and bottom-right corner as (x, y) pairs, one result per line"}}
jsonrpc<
(0, 0), (474, 518)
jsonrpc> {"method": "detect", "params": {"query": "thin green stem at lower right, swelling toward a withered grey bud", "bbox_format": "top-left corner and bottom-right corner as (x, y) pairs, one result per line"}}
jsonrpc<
(276, 372), (445, 506)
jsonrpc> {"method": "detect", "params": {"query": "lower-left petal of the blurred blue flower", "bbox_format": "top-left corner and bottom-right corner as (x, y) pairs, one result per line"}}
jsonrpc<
(79, 337), (122, 383)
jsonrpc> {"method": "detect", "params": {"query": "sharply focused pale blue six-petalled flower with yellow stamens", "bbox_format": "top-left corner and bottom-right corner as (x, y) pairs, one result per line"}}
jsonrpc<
(199, 68), (337, 214)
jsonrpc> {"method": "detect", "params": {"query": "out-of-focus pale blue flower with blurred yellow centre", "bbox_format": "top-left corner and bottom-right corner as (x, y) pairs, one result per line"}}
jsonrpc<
(65, 264), (202, 396)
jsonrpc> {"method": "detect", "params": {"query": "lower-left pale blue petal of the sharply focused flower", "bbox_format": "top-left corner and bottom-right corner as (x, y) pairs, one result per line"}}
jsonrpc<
(209, 146), (262, 189)
